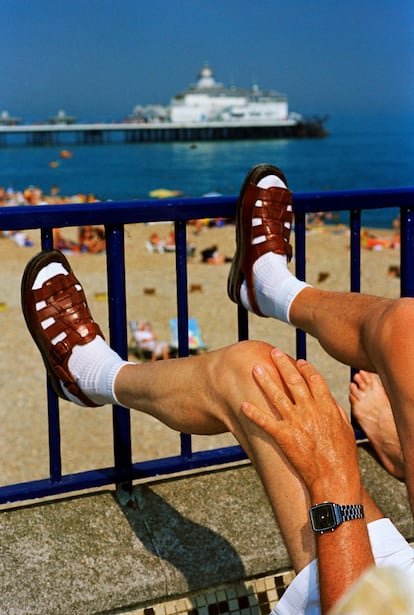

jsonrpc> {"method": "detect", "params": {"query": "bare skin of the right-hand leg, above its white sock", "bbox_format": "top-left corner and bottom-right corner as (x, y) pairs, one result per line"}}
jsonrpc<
(290, 288), (414, 512)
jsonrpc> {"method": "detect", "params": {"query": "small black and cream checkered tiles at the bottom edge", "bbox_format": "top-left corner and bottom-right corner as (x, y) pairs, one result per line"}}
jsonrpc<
(124, 571), (294, 615)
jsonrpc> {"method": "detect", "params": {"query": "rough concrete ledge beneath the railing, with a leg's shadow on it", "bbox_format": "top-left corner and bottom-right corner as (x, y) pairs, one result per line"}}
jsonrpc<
(0, 450), (414, 615)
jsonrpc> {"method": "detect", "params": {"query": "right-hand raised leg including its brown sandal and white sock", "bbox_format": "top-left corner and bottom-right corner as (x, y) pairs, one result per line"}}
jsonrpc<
(220, 159), (414, 513)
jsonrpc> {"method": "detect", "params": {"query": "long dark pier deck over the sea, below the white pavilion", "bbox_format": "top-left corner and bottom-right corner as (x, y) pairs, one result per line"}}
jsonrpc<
(0, 120), (327, 147)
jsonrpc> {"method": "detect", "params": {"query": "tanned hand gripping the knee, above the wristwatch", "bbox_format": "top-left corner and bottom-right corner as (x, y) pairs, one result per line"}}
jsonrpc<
(242, 349), (361, 503)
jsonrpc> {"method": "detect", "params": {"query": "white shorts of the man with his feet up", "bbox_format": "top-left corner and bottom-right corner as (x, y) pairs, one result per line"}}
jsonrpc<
(271, 519), (414, 615)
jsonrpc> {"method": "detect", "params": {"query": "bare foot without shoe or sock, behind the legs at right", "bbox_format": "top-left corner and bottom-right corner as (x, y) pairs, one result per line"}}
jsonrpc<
(349, 370), (404, 480)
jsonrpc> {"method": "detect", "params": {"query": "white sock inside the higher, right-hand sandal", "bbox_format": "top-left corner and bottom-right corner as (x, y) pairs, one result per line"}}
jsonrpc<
(240, 175), (309, 324)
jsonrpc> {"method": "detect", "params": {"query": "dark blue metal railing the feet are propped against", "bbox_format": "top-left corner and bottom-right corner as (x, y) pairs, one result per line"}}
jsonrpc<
(0, 188), (414, 503)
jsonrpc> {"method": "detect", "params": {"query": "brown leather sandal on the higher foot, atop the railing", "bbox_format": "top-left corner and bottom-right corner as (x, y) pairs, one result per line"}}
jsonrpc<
(227, 164), (293, 316)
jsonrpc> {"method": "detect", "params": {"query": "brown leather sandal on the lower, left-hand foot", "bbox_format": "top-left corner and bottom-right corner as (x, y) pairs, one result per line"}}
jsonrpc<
(21, 250), (104, 407)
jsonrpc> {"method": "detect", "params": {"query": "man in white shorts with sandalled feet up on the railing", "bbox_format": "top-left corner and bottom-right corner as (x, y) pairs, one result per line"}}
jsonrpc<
(22, 165), (414, 615)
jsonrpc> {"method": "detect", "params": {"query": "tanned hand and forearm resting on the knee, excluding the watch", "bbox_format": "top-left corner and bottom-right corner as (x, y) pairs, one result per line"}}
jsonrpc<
(242, 350), (374, 612)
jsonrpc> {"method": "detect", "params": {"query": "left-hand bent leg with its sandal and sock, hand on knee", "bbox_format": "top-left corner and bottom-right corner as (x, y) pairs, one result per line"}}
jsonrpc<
(22, 251), (381, 570)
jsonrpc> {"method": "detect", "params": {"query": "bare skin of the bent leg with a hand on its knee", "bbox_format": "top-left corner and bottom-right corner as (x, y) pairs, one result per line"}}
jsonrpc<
(115, 341), (381, 571)
